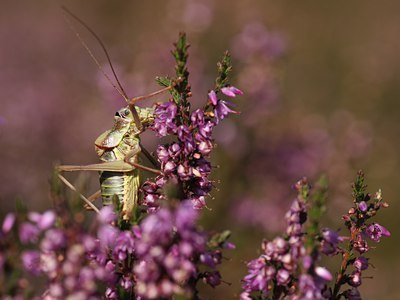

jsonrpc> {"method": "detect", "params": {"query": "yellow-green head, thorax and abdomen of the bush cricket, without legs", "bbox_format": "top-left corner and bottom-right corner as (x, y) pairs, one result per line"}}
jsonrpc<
(95, 107), (154, 219)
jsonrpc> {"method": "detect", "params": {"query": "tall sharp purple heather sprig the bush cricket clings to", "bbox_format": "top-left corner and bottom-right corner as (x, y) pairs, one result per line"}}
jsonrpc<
(142, 34), (243, 211)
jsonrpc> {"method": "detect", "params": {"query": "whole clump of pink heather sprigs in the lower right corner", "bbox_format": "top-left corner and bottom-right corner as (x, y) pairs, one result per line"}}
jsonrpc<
(240, 171), (390, 300)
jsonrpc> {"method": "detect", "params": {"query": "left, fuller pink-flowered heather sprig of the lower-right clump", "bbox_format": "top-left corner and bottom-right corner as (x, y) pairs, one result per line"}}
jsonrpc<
(241, 179), (332, 300)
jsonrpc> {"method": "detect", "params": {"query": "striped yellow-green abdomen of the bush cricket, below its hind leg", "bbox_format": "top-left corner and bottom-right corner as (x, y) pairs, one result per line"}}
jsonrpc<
(100, 170), (140, 219)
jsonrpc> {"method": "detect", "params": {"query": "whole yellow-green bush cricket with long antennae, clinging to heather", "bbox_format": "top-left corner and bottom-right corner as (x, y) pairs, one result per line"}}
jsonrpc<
(57, 7), (168, 220)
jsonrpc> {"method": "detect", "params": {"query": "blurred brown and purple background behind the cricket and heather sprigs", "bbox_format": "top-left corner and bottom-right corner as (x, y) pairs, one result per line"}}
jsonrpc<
(0, 0), (400, 299)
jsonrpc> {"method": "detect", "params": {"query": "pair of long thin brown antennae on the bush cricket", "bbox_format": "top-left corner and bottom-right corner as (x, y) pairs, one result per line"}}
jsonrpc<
(61, 6), (142, 128)
